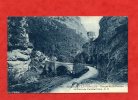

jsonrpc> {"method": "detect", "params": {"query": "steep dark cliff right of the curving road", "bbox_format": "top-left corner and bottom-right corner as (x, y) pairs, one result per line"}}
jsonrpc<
(83, 17), (128, 81)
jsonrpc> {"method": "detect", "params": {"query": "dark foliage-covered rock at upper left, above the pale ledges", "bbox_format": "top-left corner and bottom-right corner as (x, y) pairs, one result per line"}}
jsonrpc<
(8, 17), (32, 50)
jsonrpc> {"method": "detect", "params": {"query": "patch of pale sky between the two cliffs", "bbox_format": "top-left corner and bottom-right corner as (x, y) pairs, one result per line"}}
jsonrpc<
(80, 16), (102, 37)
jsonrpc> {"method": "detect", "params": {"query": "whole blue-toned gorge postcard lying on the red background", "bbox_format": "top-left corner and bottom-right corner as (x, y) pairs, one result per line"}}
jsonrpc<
(7, 16), (128, 93)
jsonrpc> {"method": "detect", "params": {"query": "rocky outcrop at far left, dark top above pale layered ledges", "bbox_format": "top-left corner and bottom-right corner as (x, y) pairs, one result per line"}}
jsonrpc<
(7, 17), (32, 84)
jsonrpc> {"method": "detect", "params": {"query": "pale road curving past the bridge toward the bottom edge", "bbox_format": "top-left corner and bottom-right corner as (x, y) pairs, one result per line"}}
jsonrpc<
(50, 66), (98, 93)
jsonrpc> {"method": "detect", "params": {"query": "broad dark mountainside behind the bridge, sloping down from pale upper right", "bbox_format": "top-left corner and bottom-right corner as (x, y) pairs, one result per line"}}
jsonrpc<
(28, 17), (88, 62)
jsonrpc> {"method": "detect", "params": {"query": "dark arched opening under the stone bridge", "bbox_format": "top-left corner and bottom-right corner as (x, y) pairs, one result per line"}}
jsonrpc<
(56, 66), (69, 76)
